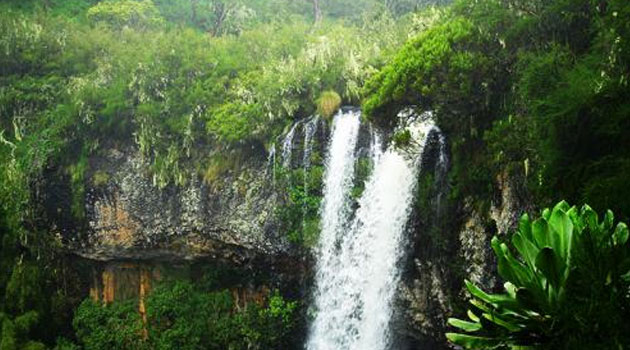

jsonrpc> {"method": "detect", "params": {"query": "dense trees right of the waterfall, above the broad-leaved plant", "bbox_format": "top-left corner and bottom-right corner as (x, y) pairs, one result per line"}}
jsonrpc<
(363, 0), (630, 219)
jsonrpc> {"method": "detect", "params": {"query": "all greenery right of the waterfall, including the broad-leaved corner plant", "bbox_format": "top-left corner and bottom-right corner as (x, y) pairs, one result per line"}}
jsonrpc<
(363, 0), (630, 349)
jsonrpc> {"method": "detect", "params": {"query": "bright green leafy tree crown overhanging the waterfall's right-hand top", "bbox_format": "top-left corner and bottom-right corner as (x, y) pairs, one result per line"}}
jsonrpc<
(363, 13), (487, 125)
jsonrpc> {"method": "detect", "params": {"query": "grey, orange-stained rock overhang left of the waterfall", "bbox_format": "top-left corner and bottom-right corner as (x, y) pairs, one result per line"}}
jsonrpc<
(63, 147), (291, 262)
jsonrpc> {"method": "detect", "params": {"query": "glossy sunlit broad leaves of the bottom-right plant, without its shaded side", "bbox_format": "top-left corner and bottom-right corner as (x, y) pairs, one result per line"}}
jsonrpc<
(446, 201), (630, 349)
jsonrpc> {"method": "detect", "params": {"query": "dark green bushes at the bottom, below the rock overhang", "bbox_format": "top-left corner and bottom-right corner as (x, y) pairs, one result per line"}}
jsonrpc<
(73, 281), (297, 350)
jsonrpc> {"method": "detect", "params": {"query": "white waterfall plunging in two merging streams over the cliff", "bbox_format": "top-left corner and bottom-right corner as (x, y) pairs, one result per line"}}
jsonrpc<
(306, 109), (435, 350)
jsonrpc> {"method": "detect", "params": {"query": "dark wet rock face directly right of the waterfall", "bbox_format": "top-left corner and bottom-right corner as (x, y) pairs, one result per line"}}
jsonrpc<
(394, 133), (532, 350)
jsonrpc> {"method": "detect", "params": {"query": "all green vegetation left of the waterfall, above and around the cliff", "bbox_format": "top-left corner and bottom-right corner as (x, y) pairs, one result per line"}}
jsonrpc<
(0, 0), (425, 350)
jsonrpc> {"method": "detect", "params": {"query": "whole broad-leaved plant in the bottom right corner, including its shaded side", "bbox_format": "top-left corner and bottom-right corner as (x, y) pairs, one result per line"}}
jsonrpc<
(446, 202), (630, 349)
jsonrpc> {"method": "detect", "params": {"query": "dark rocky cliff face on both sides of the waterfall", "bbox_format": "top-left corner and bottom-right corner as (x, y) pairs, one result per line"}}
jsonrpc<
(42, 112), (531, 349)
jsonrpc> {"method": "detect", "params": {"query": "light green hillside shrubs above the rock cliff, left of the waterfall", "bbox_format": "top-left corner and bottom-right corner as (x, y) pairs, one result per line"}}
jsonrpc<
(0, 4), (404, 189)
